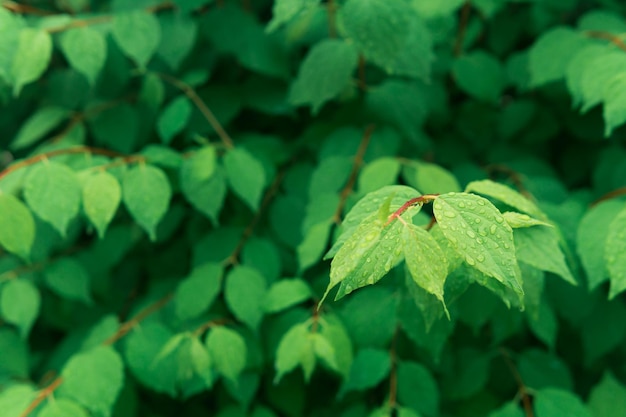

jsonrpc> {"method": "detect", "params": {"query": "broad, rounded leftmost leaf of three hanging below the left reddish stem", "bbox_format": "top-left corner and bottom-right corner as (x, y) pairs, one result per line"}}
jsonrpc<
(24, 161), (81, 236)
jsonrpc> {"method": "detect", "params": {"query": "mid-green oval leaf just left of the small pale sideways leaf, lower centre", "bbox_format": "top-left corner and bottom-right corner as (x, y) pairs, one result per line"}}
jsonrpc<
(224, 266), (267, 330)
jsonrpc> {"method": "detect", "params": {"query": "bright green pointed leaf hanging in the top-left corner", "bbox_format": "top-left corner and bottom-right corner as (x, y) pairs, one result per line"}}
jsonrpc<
(11, 28), (52, 96)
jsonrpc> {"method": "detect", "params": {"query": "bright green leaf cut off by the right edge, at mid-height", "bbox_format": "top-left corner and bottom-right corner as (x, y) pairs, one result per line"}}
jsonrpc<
(604, 209), (626, 299)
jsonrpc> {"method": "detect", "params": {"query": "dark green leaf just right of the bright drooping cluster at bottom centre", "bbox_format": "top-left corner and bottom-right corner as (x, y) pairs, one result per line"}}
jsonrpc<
(338, 349), (391, 396)
